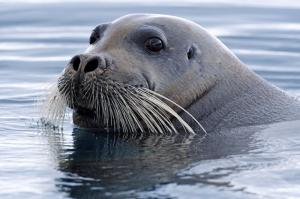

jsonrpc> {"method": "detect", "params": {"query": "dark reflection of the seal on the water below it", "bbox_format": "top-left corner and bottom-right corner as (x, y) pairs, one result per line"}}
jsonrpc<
(56, 128), (254, 198)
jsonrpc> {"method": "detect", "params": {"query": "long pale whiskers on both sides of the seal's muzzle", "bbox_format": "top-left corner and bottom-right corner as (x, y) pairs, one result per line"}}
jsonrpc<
(41, 78), (205, 135)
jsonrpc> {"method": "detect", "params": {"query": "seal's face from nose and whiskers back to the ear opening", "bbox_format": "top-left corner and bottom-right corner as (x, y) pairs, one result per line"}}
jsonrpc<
(53, 15), (211, 134)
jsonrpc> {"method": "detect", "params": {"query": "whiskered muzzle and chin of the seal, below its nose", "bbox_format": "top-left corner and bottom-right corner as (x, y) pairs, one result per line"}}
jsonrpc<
(46, 79), (206, 135)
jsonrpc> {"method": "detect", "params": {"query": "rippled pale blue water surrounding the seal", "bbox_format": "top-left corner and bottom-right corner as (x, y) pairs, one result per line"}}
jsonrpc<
(0, 1), (300, 199)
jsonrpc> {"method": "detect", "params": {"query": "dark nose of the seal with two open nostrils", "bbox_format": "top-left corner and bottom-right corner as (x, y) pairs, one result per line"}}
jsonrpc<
(70, 55), (110, 73)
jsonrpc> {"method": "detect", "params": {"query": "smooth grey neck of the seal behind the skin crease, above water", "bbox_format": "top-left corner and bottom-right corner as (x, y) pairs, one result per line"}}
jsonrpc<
(184, 64), (300, 131)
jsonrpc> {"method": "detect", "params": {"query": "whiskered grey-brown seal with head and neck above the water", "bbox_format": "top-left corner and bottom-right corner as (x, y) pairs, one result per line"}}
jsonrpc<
(42, 14), (300, 133)
